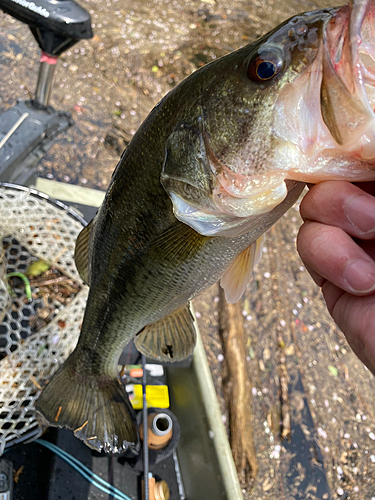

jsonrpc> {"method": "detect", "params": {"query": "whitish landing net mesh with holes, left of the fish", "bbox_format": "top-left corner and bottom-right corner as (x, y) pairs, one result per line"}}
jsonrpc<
(0, 186), (88, 456)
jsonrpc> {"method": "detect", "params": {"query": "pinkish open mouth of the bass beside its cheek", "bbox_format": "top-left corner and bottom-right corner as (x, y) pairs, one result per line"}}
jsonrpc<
(320, 0), (375, 160)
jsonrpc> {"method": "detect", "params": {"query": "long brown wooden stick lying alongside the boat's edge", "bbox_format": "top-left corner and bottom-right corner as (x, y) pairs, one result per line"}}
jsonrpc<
(219, 288), (258, 485)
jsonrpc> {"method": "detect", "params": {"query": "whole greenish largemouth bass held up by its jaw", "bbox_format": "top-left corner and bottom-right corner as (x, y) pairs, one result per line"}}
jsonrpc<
(37, 0), (375, 452)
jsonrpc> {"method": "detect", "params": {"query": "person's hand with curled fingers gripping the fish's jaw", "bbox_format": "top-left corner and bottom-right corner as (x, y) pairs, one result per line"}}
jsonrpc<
(297, 181), (375, 375)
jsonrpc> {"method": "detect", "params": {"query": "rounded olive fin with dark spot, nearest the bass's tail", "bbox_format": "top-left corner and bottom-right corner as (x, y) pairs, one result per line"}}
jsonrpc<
(134, 304), (200, 362)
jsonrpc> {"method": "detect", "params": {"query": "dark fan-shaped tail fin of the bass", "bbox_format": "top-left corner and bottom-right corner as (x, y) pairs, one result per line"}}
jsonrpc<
(36, 356), (138, 453)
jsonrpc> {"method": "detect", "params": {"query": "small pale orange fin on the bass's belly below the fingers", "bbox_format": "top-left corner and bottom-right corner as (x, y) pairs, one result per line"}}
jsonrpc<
(220, 235), (264, 304)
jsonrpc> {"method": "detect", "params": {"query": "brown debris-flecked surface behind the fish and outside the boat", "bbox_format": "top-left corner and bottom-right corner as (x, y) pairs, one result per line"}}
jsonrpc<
(0, 0), (375, 500)
